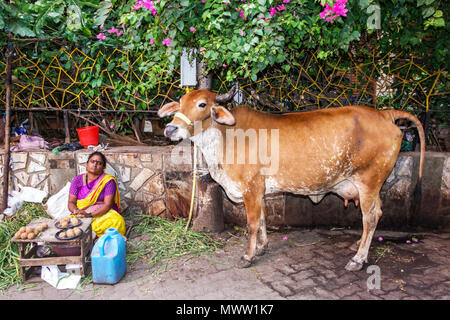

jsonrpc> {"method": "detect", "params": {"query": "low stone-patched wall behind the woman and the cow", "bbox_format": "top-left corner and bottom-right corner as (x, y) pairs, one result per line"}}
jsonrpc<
(0, 146), (450, 230)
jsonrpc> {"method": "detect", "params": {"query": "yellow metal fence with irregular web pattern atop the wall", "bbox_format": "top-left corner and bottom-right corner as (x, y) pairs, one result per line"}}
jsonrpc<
(0, 48), (450, 117)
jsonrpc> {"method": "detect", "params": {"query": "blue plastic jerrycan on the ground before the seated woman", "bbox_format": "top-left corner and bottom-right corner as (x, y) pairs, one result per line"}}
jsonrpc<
(91, 228), (127, 284)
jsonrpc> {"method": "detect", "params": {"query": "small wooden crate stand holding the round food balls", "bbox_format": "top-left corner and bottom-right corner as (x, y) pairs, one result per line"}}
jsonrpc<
(11, 218), (93, 282)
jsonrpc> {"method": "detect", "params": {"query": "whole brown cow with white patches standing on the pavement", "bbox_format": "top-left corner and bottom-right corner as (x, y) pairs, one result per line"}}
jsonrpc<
(158, 90), (425, 271)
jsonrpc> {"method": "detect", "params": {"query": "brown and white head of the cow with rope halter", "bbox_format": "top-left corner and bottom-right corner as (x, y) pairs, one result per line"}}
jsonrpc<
(158, 90), (235, 141)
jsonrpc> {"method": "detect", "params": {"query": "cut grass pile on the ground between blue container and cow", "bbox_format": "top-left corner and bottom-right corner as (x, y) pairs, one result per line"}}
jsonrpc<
(127, 215), (224, 273)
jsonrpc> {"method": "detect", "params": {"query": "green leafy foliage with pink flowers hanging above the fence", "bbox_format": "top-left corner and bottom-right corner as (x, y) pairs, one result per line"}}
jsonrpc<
(0, 0), (450, 115)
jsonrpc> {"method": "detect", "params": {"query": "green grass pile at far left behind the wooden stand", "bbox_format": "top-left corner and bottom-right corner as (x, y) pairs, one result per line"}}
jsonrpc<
(0, 202), (51, 290)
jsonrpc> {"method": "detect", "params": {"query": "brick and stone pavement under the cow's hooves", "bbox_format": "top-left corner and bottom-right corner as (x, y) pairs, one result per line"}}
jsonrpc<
(0, 229), (450, 300)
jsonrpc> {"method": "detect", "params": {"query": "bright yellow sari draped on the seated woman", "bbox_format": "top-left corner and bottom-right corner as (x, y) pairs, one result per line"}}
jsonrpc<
(77, 174), (125, 237)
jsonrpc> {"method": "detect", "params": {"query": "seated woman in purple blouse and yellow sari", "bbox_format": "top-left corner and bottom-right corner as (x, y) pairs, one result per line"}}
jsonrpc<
(68, 152), (125, 237)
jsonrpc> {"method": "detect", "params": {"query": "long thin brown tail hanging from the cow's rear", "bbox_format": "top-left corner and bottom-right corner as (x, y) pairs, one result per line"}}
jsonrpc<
(384, 110), (425, 212)
